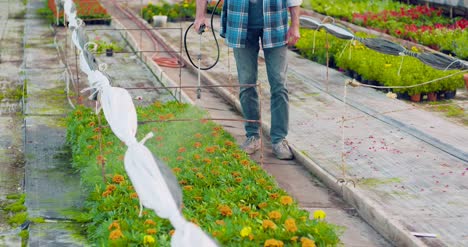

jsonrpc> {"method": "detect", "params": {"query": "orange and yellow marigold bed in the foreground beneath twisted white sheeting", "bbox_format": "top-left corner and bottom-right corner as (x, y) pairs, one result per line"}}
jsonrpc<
(67, 102), (339, 246)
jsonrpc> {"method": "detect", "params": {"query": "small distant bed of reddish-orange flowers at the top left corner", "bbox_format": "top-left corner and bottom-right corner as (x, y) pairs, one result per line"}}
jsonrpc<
(47, 0), (111, 25)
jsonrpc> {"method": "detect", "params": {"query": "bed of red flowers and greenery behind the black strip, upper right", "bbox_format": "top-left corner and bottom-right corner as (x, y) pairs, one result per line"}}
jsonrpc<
(311, 0), (468, 59)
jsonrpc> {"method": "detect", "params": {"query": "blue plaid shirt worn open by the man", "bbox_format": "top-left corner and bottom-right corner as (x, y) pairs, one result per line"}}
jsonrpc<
(220, 0), (302, 48)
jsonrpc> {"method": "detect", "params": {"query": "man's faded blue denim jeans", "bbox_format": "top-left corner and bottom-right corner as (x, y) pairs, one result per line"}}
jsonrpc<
(233, 29), (289, 144)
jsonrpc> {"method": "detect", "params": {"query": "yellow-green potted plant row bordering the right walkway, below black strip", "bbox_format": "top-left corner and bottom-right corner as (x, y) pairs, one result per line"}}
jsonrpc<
(296, 30), (464, 98)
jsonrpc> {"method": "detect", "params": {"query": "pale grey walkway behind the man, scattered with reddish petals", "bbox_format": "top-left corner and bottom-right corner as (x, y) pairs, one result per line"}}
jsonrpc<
(149, 14), (468, 246)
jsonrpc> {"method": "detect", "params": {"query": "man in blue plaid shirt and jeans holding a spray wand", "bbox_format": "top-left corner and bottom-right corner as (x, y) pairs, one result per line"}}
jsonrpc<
(194, 0), (302, 159)
